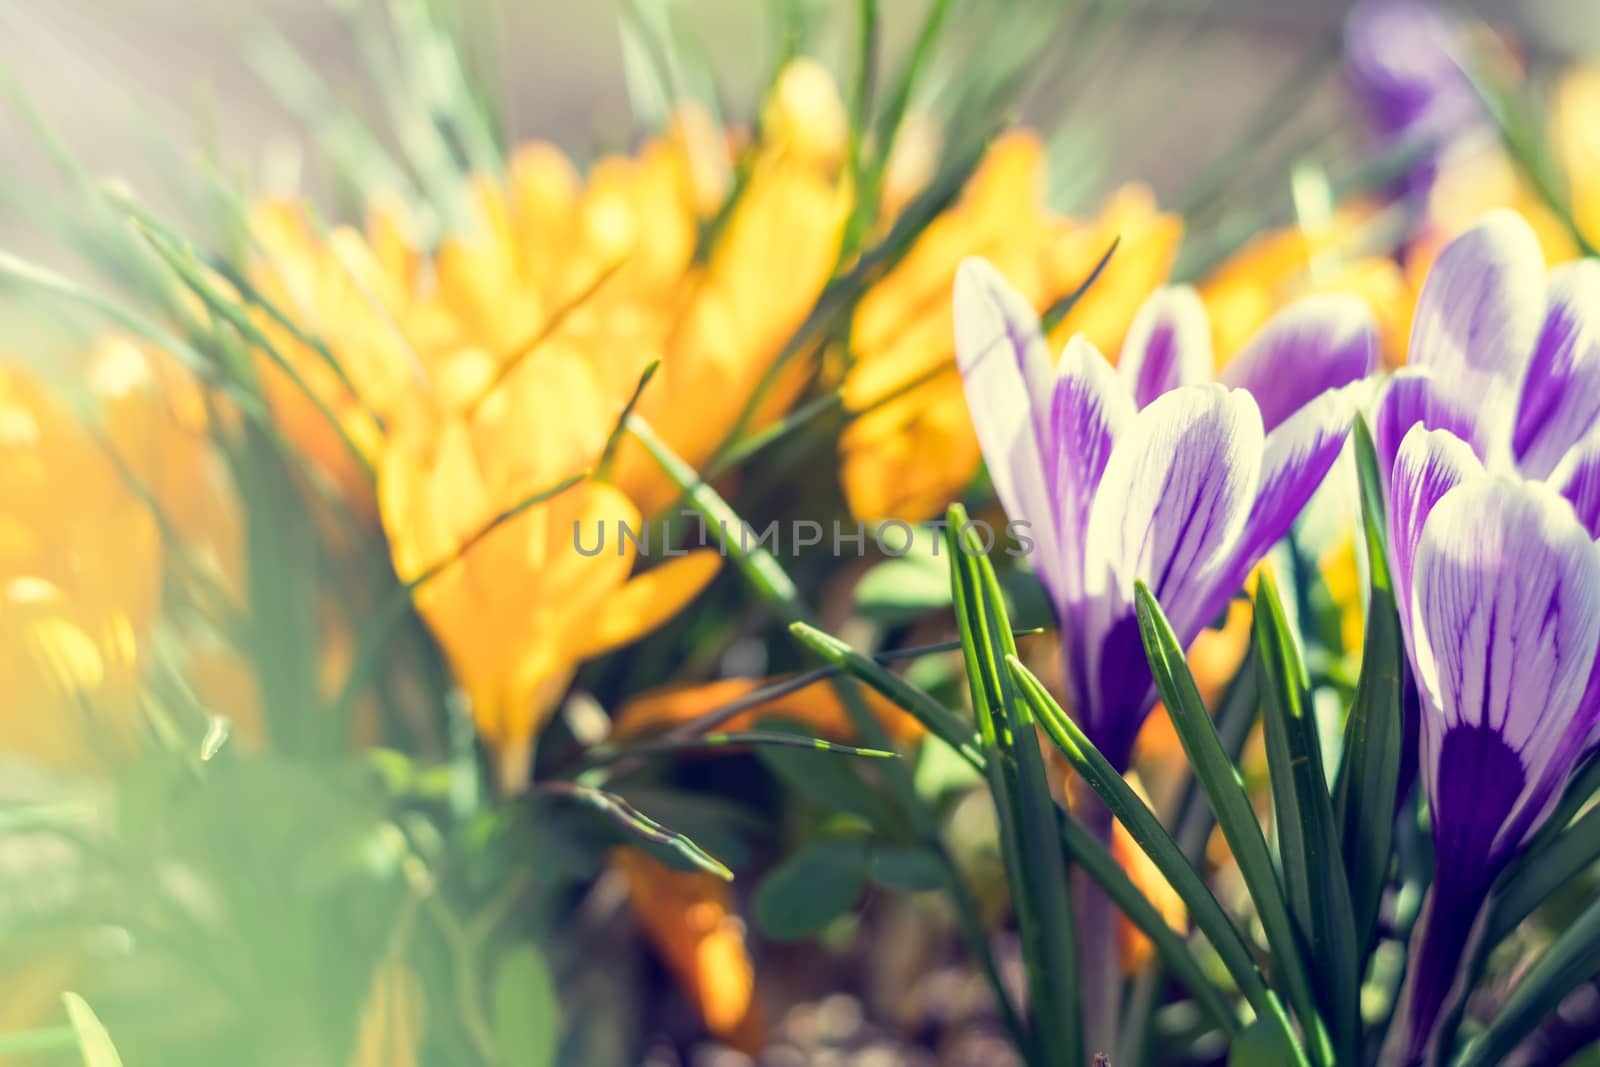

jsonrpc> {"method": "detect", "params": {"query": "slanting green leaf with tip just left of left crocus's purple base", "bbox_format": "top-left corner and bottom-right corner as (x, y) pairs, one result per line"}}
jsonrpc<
(1006, 656), (1307, 1065)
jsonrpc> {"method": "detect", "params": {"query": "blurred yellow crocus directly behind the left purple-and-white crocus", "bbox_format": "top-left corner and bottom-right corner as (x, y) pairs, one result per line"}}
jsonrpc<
(840, 130), (1182, 522)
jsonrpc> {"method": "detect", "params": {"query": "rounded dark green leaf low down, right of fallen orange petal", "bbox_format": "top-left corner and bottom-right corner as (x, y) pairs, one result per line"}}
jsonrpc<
(752, 837), (872, 941)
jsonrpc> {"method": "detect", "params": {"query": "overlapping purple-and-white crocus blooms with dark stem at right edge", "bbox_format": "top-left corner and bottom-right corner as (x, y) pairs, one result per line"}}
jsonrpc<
(1378, 213), (1600, 1062)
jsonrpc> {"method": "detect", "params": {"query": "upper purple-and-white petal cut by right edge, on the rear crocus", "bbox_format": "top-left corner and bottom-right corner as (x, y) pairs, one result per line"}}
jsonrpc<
(1512, 259), (1600, 478)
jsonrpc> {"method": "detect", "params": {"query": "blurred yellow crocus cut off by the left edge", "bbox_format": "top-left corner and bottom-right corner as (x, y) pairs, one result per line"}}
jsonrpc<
(0, 366), (162, 769)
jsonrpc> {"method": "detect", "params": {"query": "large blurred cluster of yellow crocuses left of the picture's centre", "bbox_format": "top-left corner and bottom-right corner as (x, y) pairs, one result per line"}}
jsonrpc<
(244, 61), (851, 781)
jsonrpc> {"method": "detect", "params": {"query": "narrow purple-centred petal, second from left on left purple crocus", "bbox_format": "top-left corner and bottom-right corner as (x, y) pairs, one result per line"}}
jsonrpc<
(1045, 334), (1134, 614)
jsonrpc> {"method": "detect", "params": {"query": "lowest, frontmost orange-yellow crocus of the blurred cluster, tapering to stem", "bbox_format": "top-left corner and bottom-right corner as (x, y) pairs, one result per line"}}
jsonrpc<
(378, 350), (720, 787)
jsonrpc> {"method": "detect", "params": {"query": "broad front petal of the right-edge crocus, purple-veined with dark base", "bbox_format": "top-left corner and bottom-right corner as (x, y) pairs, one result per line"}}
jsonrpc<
(1414, 477), (1600, 864)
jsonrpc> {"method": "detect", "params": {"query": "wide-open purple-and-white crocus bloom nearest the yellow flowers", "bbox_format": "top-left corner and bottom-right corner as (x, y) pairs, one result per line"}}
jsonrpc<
(955, 259), (1376, 769)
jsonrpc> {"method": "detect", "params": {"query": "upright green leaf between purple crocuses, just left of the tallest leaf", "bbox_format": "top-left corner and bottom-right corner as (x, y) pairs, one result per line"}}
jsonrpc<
(1254, 569), (1360, 1061)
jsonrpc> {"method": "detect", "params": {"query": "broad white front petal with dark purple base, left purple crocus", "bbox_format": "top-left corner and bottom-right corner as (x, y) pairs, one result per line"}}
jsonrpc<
(1066, 382), (1266, 763)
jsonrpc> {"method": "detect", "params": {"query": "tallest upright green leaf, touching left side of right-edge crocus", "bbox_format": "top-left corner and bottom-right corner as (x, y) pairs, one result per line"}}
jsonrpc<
(1334, 419), (1405, 969)
